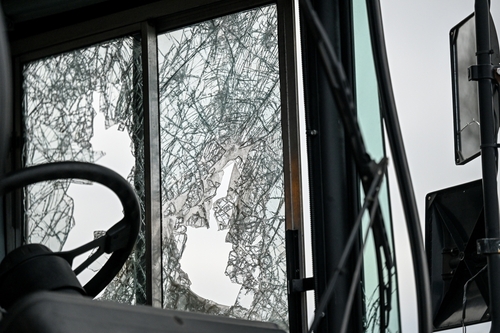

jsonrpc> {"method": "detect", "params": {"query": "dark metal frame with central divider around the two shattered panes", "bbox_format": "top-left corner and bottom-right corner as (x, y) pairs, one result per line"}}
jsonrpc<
(5, 0), (307, 332)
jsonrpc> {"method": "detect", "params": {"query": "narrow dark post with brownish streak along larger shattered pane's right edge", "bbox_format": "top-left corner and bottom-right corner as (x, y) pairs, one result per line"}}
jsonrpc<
(277, 0), (307, 333)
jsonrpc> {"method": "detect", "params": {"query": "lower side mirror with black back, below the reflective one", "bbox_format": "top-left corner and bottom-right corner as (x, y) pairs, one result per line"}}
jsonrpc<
(425, 180), (490, 331)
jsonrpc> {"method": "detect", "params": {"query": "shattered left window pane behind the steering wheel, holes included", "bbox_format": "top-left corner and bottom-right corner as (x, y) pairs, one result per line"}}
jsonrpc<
(22, 37), (145, 303)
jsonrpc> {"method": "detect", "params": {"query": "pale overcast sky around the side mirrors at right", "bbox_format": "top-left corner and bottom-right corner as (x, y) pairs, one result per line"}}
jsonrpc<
(380, 0), (500, 333)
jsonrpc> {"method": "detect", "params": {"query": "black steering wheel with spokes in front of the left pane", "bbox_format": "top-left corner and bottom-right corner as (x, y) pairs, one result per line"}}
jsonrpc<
(0, 162), (140, 297)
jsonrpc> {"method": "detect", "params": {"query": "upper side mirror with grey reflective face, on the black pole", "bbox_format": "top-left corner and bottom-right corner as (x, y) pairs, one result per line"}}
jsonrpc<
(450, 14), (500, 165)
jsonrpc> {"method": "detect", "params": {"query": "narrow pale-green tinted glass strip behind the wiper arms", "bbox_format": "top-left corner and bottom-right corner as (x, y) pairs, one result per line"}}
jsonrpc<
(353, 0), (401, 332)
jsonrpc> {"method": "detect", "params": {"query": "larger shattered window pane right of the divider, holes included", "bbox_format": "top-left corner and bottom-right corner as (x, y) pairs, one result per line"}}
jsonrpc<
(158, 6), (288, 328)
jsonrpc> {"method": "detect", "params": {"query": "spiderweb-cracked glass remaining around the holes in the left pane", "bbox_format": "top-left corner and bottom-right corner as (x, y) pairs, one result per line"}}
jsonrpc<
(23, 37), (145, 303)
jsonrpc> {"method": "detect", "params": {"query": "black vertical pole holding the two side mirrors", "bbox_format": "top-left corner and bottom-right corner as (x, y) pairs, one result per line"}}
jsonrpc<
(474, 0), (500, 332)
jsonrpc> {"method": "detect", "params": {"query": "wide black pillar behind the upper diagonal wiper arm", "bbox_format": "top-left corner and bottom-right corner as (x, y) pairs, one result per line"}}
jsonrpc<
(301, 0), (364, 333)
